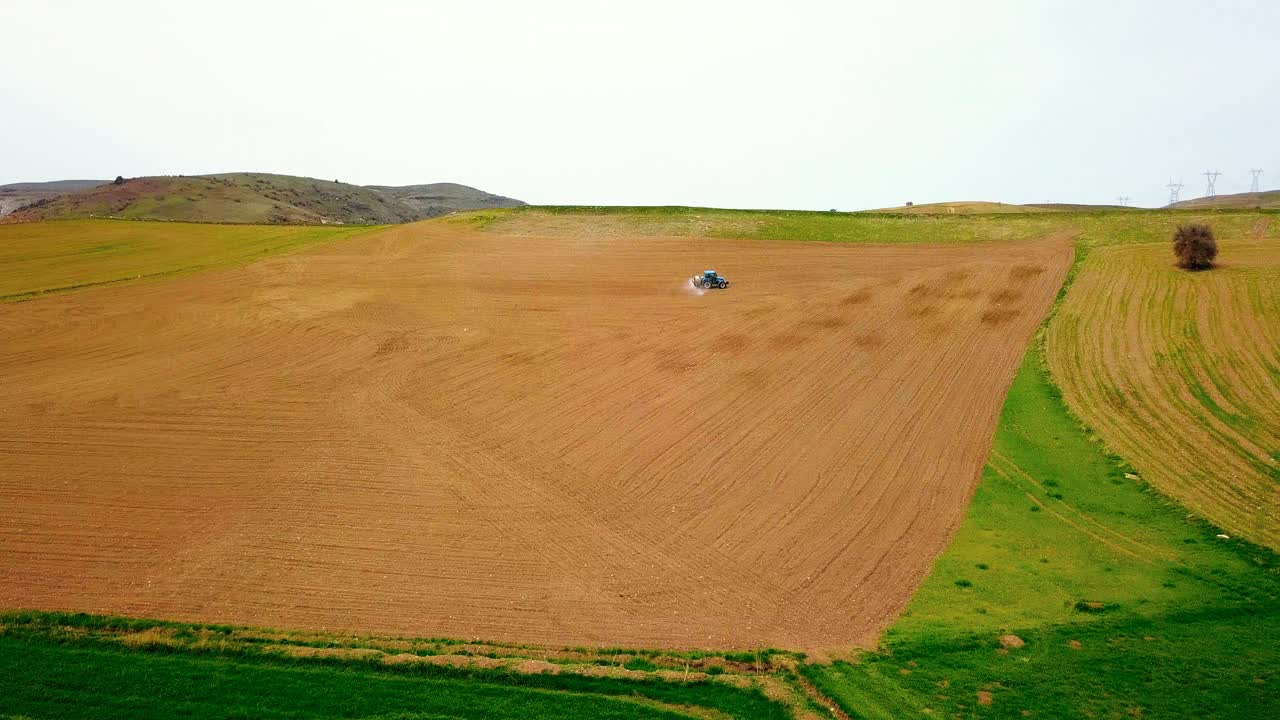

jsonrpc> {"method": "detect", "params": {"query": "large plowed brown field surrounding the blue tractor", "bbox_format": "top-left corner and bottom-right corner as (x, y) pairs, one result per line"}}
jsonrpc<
(0, 223), (1071, 650)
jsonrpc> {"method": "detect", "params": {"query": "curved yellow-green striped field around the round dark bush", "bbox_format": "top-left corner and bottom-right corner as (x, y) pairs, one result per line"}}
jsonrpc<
(1046, 217), (1280, 548)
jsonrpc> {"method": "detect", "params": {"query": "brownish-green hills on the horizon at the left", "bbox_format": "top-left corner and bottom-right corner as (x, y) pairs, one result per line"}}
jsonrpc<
(0, 173), (524, 224)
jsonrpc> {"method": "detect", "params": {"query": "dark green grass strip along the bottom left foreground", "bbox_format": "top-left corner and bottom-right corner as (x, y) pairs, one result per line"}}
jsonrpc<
(0, 612), (791, 720)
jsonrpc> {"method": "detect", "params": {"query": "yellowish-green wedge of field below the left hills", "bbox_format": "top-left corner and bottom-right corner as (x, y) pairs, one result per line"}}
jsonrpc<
(0, 220), (375, 301)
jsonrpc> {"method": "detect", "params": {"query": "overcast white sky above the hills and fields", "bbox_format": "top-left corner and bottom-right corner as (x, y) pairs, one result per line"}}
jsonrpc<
(0, 0), (1280, 210)
